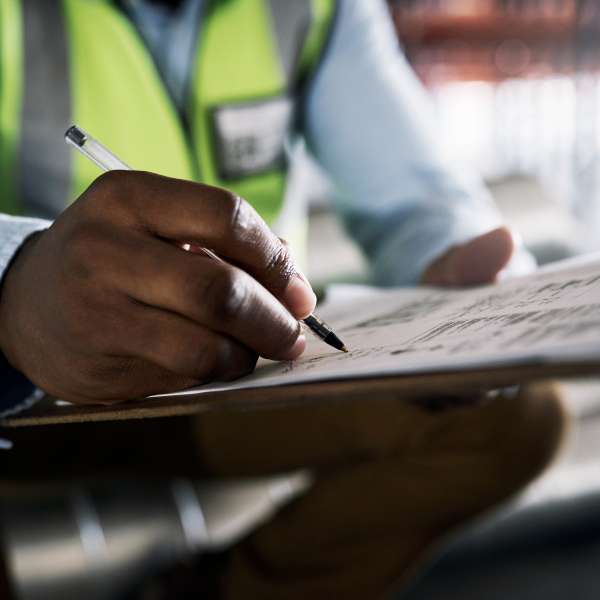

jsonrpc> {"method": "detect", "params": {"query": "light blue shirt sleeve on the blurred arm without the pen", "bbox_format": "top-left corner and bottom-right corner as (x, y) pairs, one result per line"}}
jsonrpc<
(305, 0), (535, 285)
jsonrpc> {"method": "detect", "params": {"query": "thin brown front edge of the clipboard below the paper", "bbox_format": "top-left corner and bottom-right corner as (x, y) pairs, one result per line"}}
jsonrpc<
(0, 358), (600, 428)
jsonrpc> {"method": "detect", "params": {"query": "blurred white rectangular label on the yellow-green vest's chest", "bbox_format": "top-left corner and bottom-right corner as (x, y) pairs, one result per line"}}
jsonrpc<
(214, 98), (293, 180)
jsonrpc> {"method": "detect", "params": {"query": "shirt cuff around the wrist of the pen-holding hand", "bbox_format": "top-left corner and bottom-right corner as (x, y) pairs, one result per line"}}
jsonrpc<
(0, 214), (51, 417)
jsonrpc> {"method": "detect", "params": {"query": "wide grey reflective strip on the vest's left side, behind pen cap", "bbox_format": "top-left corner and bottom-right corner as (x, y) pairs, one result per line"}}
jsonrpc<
(18, 0), (71, 217)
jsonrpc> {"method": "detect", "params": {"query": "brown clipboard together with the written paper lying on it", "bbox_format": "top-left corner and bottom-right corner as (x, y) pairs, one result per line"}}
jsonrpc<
(7, 255), (600, 427)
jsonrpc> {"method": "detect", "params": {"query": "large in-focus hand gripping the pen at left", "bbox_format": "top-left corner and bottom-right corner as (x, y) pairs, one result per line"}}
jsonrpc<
(0, 171), (316, 403)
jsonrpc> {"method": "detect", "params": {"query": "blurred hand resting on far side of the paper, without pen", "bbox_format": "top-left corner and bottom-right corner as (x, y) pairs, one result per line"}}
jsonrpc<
(421, 227), (515, 286)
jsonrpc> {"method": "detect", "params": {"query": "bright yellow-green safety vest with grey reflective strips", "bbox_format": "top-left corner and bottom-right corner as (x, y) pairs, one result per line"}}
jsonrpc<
(0, 0), (335, 232)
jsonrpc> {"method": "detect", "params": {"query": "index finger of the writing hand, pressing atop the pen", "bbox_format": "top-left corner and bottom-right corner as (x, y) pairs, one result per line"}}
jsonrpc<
(97, 171), (316, 318)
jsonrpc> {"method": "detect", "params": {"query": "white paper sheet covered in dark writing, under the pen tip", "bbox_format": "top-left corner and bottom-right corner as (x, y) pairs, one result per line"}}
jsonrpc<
(162, 256), (600, 394)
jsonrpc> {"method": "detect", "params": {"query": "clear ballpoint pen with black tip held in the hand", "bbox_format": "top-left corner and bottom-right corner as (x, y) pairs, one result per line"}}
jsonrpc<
(65, 125), (348, 352)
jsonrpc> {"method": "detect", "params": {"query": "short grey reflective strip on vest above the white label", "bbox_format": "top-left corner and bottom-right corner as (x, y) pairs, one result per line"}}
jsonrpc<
(269, 0), (312, 87)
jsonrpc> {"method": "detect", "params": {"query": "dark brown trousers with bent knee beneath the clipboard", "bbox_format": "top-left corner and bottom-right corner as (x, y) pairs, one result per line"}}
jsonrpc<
(0, 384), (567, 600)
